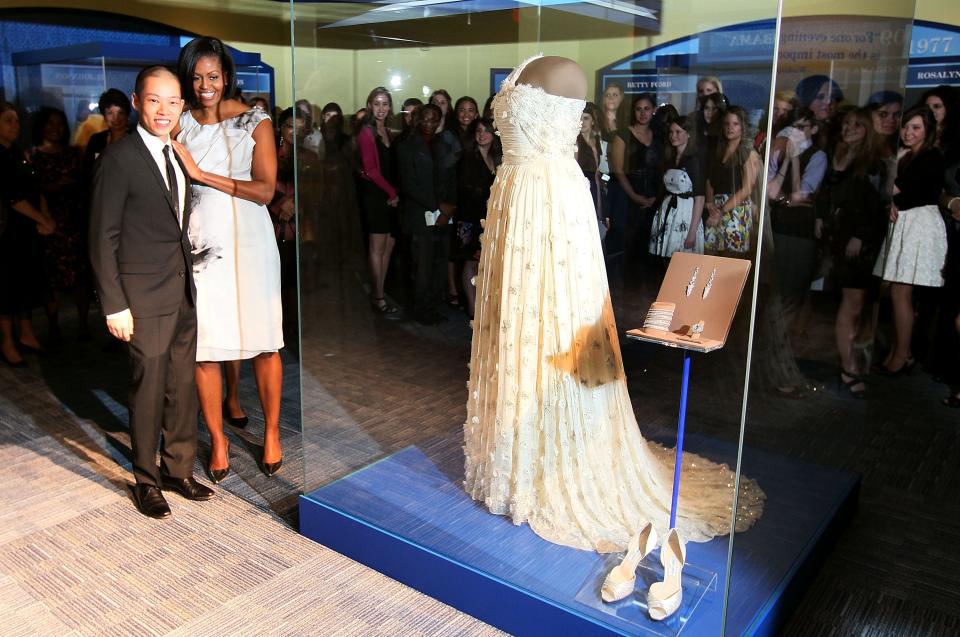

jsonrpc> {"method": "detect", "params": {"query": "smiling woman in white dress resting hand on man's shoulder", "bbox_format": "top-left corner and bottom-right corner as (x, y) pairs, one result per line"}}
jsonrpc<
(174, 37), (283, 483)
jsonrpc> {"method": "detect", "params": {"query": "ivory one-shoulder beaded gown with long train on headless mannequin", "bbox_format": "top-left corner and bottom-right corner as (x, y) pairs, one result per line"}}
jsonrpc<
(464, 60), (764, 552)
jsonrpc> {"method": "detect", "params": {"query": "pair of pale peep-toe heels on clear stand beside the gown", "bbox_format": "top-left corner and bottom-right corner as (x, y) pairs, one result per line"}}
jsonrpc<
(600, 522), (687, 621)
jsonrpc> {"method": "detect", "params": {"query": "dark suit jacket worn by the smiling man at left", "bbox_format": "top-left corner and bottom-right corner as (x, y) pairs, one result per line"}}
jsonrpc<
(90, 131), (197, 318)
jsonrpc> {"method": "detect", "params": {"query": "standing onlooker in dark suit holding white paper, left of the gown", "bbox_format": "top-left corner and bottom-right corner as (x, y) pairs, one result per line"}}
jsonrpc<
(398, 104), (457, 325)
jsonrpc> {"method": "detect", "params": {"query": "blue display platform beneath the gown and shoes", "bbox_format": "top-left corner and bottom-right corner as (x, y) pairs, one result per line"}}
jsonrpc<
(300, 432), (860, 636)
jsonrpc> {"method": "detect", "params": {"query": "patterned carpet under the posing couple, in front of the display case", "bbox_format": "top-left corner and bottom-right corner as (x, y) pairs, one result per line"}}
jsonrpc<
(0, 340), (501, 637)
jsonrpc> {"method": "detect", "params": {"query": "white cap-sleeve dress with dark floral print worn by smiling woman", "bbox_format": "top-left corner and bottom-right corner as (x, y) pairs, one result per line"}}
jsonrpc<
(177, 109), (283, 361)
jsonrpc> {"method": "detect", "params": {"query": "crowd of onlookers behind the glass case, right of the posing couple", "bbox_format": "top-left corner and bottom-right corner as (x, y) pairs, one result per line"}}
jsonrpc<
(280, 75), (960, 406)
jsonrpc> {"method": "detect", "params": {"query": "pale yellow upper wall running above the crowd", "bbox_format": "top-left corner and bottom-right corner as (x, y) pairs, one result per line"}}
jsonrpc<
(7, 0), (960, 110)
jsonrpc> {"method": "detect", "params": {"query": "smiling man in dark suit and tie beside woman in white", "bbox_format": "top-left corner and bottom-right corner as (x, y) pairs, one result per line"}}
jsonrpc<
(90, 66), (213, 518)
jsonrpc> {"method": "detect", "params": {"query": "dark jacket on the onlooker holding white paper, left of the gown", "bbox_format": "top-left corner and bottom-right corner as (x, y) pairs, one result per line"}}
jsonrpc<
(397, 132), (457, 234)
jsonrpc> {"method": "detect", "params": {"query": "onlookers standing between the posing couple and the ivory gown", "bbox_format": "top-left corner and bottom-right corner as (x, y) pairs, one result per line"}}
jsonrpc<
(271, 87), (502, 325)
